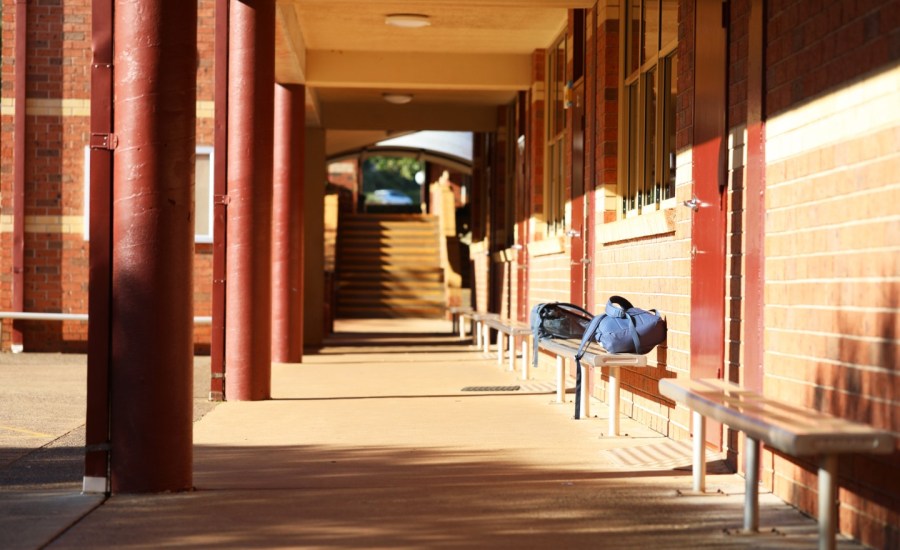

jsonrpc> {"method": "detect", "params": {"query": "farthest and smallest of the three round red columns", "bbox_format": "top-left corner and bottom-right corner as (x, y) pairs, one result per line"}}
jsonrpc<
(272, 84), (306, 363)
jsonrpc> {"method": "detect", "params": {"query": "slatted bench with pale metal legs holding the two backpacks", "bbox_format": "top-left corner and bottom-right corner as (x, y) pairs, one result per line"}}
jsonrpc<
(538, 338), (647, 435)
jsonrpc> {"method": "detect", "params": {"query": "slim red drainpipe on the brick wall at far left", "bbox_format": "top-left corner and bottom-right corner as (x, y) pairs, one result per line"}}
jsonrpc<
(11, 0), (28, 353)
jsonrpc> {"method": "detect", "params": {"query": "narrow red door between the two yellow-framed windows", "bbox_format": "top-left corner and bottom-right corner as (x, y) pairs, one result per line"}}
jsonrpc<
(566, 85), (590, 306)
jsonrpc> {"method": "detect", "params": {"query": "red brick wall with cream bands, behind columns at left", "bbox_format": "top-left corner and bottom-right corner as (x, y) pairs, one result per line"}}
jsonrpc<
(0, 0), (215, 352)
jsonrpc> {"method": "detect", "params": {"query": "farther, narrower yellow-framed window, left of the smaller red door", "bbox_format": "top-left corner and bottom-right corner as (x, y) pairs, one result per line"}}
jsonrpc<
(544, 33), (568, 234)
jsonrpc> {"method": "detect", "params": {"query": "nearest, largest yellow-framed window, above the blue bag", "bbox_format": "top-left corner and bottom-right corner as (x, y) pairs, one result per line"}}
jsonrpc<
(619, 0), (678, 217)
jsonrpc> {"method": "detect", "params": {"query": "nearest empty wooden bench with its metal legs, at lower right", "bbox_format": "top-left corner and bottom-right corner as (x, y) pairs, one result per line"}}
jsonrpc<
(659, 378), (894, 549)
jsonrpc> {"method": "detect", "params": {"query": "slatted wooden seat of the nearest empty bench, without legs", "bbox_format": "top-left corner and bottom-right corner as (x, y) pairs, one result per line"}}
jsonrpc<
(659, 378), (894, 456)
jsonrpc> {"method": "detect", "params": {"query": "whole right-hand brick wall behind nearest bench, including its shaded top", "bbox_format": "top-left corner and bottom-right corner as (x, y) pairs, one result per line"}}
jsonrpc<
(764, 1), (900, 548)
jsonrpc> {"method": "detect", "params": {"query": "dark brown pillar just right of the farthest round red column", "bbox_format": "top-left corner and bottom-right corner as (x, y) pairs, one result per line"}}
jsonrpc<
(303, 128), (328, 347)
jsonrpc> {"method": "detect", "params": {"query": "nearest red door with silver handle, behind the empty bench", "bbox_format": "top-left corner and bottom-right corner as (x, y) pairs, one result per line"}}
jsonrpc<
(687, 2), (728, 448)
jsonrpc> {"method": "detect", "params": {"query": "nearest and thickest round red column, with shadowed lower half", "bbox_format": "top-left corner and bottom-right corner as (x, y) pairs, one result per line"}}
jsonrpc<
(110, 0), (197, 493)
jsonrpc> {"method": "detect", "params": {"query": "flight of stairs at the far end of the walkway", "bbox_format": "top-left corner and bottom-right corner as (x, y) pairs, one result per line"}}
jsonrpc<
(335, 214), (446, 318)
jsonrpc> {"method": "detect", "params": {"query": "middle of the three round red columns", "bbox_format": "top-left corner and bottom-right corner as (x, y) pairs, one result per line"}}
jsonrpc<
(225, 0), (275, 400)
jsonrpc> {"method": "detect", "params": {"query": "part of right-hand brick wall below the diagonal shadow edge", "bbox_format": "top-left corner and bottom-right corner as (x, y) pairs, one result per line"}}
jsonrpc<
(765, 61), (900, 546)
